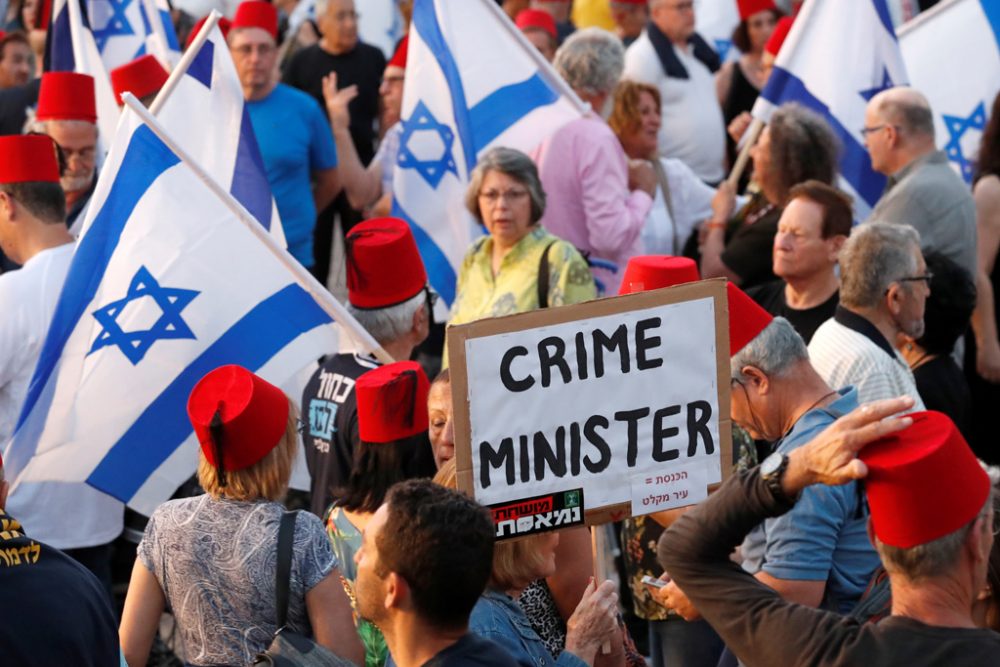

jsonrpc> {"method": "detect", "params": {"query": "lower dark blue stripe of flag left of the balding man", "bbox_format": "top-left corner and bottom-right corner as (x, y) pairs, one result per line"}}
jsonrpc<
(761, 67), (885, 206)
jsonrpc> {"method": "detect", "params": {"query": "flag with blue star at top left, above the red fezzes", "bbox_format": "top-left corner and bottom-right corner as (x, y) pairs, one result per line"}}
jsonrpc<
(87, 0), (180, 71)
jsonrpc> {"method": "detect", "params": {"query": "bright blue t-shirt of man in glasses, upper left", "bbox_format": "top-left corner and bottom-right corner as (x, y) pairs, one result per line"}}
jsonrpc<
(246, 83), (337, 268)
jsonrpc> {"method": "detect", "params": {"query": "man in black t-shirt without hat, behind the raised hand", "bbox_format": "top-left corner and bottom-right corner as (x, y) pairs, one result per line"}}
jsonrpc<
(284, 0), (395, 280)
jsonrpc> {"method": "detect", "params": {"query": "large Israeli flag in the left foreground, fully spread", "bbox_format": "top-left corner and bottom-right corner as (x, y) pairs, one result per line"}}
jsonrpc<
(4, 110), (339, 514)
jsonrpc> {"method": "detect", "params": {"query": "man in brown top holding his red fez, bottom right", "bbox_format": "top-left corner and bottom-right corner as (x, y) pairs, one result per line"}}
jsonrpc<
(658, 398), (1000, 667)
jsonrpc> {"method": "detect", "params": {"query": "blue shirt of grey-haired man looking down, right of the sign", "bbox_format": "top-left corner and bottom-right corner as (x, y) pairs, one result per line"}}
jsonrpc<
(744, 387), (879, 613)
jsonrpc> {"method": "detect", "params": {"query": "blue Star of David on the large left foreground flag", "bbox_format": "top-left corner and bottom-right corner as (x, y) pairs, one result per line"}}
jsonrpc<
(93, 266), (200, 366)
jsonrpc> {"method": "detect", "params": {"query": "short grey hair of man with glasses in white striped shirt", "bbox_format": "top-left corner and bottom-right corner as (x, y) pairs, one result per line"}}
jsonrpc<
(840, 222), (920, 308)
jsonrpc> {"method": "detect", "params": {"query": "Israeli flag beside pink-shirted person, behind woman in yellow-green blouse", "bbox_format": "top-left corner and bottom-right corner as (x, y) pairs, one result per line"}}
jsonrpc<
(392, 0), (585, 305)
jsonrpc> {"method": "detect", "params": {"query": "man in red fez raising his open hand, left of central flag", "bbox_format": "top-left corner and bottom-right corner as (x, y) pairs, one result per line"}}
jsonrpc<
(323, 37), (410, 217)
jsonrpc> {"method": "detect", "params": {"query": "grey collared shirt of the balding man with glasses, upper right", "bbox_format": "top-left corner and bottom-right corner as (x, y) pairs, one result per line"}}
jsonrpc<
(867, 151), (976, 273)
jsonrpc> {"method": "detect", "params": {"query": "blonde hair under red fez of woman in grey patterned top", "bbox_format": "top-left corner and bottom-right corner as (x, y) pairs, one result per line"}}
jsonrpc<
(198, 399), (299, 500)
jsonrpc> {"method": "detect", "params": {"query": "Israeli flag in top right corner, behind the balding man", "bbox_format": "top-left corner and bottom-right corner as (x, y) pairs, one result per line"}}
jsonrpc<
(899, 0), (1000, 184)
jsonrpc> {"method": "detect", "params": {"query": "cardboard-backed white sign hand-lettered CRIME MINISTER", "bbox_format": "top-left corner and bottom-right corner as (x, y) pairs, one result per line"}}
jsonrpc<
(448, 280), (732, 525)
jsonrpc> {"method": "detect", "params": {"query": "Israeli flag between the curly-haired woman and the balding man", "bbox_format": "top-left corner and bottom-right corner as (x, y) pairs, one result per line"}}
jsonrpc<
(752, 0), (908, 220)
